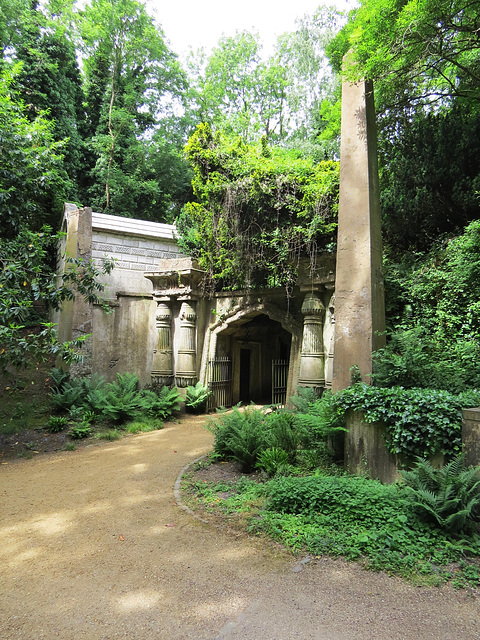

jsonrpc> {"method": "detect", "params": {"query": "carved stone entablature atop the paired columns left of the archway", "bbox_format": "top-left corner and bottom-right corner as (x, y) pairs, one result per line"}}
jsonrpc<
(145, 258), (205, 298)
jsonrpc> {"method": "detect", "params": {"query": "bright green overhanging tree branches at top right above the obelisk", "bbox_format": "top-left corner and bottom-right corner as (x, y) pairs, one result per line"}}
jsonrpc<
(329, 0), (480, 109)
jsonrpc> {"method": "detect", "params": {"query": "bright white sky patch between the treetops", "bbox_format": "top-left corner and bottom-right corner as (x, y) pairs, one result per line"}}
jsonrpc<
(147, 0), (357, 55)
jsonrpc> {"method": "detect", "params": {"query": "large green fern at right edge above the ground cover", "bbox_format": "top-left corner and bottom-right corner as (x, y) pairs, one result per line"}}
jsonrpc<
(403, 455), (480, 534)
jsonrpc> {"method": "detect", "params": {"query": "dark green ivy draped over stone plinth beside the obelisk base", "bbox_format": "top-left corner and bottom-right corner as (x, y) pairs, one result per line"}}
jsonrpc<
(335, 384), (480, 460)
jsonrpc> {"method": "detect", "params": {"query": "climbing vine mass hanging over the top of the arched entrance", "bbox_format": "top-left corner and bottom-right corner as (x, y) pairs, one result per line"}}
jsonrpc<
(178, 124), (339, 291)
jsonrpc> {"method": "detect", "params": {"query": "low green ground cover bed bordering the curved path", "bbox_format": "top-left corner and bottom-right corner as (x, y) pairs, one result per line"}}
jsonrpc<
(188, 475), (480, 587)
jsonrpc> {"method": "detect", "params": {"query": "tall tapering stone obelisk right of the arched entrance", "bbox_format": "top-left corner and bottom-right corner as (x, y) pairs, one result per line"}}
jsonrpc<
(332, 77), (385, 391)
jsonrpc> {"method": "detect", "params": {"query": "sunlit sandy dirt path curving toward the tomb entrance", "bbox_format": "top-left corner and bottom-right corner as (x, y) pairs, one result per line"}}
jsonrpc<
(0, 419), (480, 640)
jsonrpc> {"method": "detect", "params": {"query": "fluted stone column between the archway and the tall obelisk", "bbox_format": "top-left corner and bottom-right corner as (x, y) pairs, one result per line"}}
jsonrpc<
(298, 293), (325, 388)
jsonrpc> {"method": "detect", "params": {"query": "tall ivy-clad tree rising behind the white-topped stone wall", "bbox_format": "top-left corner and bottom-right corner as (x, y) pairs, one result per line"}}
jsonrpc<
(79, 0), (188, 219)
